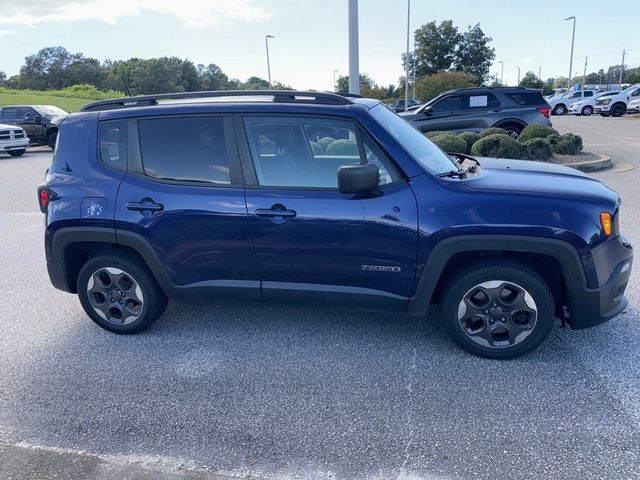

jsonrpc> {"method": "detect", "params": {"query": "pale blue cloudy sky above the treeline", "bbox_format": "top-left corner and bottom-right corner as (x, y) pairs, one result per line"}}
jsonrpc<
(0, 0), (640, 90)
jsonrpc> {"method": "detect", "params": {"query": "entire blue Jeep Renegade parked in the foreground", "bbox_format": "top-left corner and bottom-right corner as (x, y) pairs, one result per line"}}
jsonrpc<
(38, 91), (633, 358)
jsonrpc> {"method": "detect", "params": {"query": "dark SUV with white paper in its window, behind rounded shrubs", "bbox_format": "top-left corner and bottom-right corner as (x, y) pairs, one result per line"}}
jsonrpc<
(399, 87), (551, 138)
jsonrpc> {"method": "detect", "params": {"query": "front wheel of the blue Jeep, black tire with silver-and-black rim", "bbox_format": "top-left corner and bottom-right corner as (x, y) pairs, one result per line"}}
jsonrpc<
(442, 260), (555, 359)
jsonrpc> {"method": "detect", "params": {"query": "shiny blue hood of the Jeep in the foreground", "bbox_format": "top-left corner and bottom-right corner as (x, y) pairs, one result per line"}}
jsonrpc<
(465, 158), (619, 204)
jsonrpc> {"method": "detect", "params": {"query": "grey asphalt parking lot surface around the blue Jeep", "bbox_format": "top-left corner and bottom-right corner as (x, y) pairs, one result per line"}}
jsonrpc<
(0, 116), (640, 480)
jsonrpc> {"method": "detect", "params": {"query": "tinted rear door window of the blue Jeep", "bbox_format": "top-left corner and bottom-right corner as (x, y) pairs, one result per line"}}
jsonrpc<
(138, 116), (231, 185)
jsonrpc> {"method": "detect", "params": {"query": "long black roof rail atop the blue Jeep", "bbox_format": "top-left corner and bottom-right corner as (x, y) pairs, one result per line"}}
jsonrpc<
(80, 90), (353, 112)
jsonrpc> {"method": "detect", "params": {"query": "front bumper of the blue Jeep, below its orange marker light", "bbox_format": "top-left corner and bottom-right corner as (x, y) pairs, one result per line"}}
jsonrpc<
(569, 236), (633, 330)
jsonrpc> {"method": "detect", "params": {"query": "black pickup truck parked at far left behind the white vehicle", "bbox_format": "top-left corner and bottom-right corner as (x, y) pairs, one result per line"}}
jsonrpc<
(0, 105), (68, 150)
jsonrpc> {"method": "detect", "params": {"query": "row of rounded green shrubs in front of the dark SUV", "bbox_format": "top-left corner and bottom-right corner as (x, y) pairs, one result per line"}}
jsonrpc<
(425, 125), (582, 161)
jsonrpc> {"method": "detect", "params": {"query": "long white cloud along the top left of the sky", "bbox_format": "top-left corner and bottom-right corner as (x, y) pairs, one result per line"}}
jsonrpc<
(0, 0), (270, 27)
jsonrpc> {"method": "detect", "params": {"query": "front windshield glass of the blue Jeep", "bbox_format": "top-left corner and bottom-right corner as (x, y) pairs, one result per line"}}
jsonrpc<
(371, 105), (457, 175)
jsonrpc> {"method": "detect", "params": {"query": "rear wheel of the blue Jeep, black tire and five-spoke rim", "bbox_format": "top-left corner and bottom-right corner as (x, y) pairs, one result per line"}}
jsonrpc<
(77, 255), (167, 334)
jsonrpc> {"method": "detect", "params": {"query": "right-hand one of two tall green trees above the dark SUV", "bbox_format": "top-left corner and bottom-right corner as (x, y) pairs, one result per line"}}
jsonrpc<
(453, 23), (496, 85)
